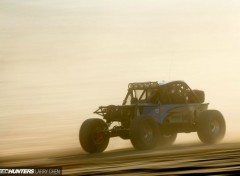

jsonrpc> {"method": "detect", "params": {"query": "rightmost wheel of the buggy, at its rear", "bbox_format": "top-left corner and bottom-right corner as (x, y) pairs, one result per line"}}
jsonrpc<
(197, 110), (226, 144)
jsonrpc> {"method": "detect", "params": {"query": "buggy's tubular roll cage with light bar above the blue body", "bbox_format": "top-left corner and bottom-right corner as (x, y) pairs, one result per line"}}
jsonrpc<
(122, 81), (200, 105)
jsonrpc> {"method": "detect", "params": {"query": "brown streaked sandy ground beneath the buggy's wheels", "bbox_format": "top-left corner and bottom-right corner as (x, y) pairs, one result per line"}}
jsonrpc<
(1, 143), (240, 175)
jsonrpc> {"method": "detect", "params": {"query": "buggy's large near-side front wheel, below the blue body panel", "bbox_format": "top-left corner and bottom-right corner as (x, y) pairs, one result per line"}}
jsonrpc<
(130, 116), (159, 150)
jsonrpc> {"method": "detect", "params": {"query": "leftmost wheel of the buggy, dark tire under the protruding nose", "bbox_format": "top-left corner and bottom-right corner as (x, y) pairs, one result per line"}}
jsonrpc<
(79, 119), (110, 153)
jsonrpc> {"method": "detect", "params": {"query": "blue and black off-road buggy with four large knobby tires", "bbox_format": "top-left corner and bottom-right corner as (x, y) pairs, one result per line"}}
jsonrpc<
(79, 81), (226, 153)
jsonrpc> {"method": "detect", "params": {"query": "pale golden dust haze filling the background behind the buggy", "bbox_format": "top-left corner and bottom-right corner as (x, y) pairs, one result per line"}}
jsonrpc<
(0, 0), (240, 160)
